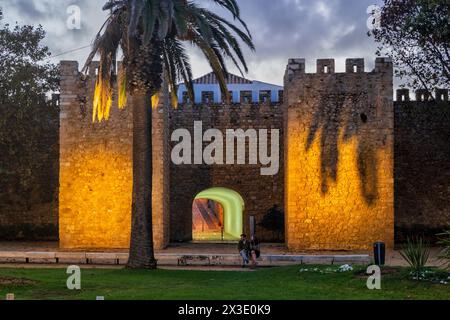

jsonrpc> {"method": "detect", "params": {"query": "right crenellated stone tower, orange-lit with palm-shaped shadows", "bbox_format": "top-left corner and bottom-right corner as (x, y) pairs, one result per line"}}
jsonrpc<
(285, 59), (394, 250)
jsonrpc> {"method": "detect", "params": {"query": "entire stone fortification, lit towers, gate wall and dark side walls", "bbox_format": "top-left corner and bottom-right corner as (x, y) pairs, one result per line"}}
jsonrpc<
(0, 59), (450, 249)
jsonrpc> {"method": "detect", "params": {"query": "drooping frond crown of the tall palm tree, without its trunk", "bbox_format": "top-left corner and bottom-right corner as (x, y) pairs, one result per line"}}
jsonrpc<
(83, 0), (255, 121)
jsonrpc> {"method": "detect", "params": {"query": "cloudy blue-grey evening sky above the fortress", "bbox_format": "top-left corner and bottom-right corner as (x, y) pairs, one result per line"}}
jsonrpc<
(0, 0), (382, 85)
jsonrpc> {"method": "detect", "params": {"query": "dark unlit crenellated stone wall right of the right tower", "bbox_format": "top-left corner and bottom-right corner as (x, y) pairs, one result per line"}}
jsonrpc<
(394, 89), (450, 242)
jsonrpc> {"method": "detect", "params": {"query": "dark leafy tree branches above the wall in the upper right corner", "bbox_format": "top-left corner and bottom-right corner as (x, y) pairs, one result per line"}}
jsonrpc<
(369, 0), (450, 92)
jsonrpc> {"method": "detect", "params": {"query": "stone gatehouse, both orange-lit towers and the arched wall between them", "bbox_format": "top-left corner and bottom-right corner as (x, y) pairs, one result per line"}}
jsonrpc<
(56, 60), (394, 249)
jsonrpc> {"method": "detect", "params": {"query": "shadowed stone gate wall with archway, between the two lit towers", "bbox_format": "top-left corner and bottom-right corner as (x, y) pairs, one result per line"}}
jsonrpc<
(170, 103), (285, 242)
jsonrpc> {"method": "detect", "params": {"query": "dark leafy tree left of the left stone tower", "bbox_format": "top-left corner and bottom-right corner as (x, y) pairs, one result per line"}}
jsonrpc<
(0, 10), (59, 212)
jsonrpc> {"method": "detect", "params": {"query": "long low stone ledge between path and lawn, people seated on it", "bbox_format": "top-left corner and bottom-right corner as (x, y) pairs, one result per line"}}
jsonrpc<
(0, 251), (370, 266)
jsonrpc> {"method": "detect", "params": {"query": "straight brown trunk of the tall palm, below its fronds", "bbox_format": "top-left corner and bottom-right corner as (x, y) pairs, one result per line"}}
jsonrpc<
(127, 92), (157, 269)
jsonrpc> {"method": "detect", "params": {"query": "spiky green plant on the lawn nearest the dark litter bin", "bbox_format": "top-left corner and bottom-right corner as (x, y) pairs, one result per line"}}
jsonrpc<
(400, 237), (430, 279)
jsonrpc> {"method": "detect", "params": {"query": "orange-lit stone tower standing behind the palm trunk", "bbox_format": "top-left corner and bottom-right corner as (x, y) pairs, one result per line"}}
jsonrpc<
(59, 61), (168, 249)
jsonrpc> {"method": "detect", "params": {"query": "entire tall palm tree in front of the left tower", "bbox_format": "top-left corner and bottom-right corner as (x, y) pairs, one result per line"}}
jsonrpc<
(84, 0), (254, 269)
